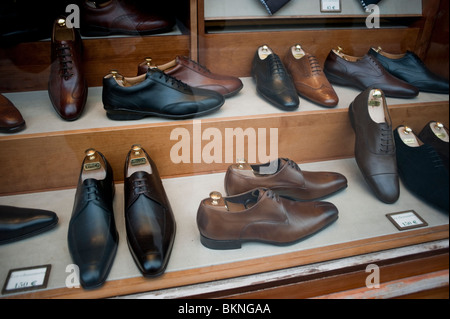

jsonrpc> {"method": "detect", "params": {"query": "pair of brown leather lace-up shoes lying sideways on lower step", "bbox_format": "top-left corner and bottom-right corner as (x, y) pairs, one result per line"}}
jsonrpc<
(197, 158), (347, 249)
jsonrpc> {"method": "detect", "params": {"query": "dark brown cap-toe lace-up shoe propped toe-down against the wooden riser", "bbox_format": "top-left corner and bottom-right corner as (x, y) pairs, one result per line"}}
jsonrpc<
(348, 89), (400, 204)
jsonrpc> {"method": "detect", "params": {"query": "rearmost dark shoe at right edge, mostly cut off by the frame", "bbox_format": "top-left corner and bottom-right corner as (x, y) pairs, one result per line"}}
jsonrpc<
(419, 121), (449, 170)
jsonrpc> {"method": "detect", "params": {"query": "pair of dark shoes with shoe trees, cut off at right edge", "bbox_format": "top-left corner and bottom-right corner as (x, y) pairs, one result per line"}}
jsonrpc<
(394, 122), (449, 213)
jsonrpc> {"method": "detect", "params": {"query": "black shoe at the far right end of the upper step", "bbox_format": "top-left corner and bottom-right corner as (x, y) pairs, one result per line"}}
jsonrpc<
(369, 48), (449, 94)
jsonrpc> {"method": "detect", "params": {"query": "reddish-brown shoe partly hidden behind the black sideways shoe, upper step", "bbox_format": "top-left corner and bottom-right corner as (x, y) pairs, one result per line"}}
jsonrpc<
(138, 56), (244, 98)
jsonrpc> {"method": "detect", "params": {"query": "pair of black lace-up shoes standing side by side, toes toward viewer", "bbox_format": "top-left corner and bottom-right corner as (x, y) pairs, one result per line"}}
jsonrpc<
(67, 145), (175, 288)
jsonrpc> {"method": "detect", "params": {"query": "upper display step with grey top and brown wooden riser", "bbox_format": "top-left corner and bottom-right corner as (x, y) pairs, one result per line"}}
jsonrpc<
(0, 78), (449, 195)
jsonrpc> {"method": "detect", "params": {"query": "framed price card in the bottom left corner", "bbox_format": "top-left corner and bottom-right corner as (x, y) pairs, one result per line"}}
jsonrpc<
(2, 265), (51, 294)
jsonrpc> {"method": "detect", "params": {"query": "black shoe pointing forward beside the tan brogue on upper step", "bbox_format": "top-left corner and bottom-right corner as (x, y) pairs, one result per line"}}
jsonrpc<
(252, 45), (300, 111)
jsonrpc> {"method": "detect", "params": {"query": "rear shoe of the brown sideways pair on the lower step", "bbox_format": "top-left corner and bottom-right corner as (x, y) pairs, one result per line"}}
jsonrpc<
(225, 158), (347, 201)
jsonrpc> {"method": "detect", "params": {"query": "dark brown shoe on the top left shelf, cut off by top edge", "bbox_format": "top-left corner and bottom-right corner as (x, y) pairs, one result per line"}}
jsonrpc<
(80, 0), (175, 36)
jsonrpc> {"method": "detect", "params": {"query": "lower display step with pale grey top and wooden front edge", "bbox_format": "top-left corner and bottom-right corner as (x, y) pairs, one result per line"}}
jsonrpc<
(0, 158), (448, 298)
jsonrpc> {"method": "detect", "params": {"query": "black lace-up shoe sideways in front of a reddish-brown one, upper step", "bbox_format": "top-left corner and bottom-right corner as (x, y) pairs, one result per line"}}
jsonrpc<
(103, 69), (225, 120)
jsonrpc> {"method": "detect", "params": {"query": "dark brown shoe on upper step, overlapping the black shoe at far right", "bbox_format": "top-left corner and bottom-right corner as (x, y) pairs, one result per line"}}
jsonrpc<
(324, 50), (419, 98)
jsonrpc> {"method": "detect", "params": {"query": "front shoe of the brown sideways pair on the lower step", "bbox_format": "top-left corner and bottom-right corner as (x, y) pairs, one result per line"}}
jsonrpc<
(197, 188), (338, 249)
